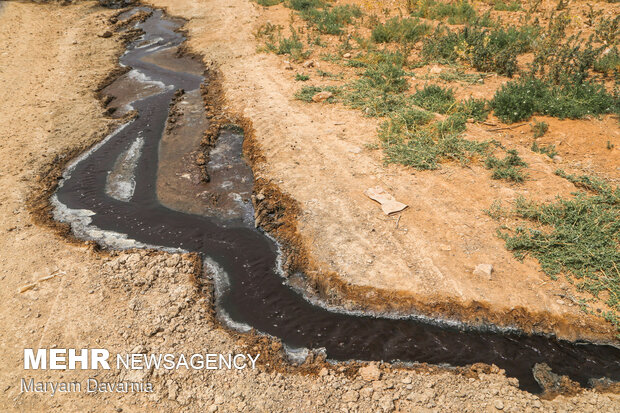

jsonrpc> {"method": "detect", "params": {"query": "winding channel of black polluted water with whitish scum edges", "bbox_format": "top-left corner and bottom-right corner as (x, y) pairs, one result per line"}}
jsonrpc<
(52, 8), (620, 392)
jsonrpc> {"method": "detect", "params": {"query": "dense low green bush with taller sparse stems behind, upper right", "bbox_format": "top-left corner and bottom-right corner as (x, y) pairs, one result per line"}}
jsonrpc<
(491, 13), (620, 122)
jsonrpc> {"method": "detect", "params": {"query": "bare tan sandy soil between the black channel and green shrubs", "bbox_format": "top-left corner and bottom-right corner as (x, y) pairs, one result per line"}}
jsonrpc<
(137, 0), (620, 339)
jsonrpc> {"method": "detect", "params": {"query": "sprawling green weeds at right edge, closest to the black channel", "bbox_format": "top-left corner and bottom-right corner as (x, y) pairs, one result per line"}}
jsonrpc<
(500, 171), (620, 331)
